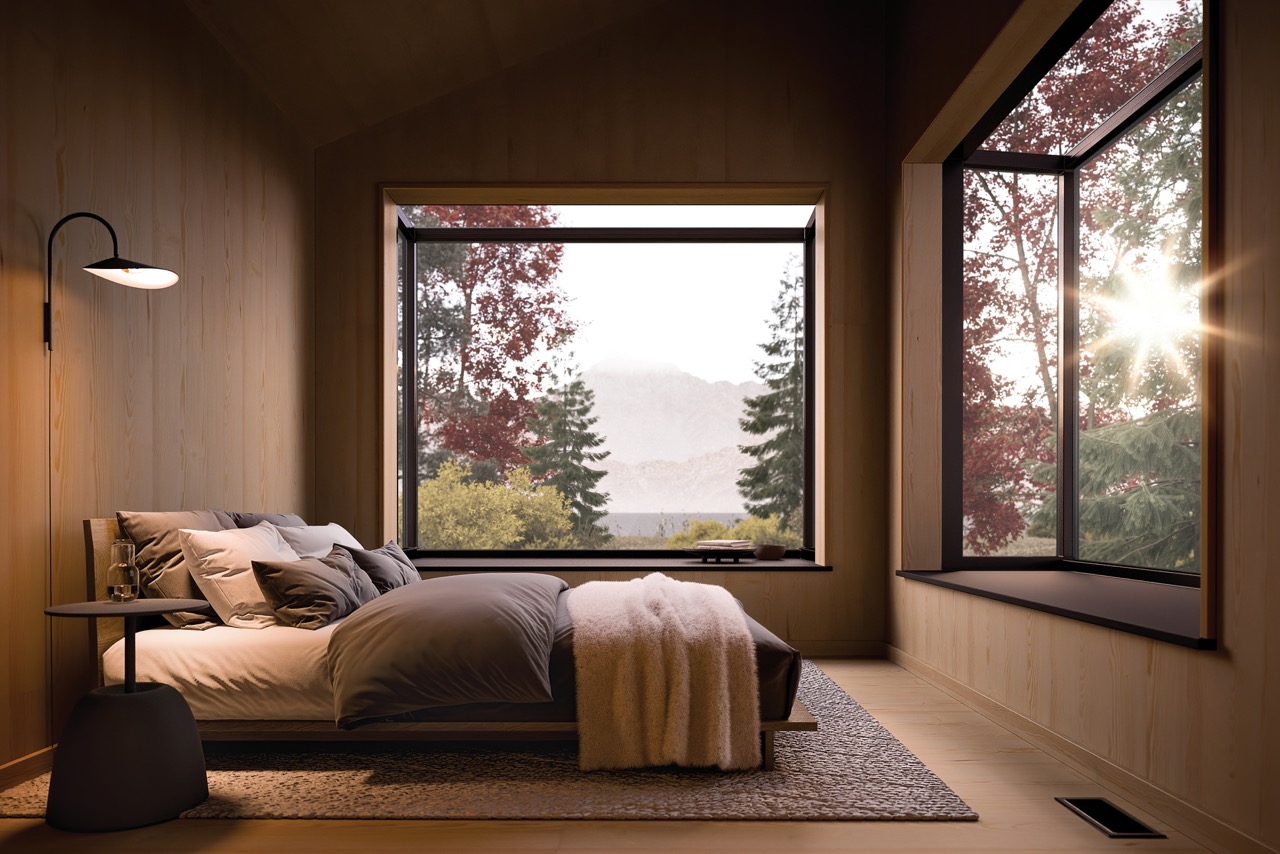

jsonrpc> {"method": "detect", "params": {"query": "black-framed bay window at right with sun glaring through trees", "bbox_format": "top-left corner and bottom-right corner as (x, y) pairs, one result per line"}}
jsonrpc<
(947, 0), (1206, 577)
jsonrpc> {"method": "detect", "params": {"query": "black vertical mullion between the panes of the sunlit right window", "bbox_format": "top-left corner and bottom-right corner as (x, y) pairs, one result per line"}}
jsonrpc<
(1057, 169), (1080, 560)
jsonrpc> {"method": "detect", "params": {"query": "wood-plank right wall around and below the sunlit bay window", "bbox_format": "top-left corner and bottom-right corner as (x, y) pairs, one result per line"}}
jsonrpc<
(890, 0), (1280, 851)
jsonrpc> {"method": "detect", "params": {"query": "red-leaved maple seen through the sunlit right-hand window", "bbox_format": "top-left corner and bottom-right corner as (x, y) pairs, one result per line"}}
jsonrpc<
(961, 0), (1198, 554)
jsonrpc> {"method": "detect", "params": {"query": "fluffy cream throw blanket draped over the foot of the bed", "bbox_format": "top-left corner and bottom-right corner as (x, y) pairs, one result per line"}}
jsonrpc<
(568, 572), (760, 771)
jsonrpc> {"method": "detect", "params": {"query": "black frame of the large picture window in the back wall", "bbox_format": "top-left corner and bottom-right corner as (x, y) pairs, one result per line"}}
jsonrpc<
(396, 205), (818, 567)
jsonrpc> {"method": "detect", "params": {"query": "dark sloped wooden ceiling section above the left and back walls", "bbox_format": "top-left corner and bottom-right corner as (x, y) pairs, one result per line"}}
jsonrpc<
(186, 0), (668, 146)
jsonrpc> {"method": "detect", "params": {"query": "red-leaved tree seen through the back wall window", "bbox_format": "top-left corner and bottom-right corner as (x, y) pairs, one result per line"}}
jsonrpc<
(410, 205), (576, 475)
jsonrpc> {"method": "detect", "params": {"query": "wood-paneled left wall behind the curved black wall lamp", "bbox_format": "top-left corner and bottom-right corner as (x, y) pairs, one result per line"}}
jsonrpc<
(0, 0), (312, 764)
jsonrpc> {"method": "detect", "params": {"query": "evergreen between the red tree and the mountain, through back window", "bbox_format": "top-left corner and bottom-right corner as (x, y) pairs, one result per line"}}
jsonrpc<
(525, 368), (612, 548)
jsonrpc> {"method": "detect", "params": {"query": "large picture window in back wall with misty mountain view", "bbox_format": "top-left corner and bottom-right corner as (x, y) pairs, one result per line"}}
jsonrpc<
(397, 205), (814, 557)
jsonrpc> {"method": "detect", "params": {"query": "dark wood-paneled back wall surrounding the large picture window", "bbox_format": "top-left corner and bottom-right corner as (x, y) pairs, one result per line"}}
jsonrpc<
(316, 0), (887, 652)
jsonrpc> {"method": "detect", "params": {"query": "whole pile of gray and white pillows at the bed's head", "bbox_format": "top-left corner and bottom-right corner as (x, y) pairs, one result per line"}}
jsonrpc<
(116, 510), (420, 629)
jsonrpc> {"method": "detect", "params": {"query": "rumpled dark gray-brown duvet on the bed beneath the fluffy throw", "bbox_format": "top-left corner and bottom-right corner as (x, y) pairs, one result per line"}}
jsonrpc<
(328, 572), (800, 729)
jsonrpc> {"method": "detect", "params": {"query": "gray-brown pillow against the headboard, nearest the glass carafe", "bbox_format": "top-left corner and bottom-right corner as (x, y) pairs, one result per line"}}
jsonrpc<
(115, 510), (234, 629)
